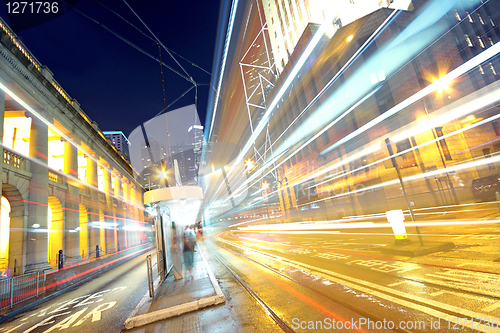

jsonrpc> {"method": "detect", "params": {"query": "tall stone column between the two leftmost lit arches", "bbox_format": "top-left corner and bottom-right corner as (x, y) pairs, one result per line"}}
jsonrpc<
(25, 116), (50, 273)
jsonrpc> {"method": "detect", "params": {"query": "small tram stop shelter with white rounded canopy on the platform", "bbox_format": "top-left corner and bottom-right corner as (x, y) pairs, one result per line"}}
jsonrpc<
(144, 186), (203, 280)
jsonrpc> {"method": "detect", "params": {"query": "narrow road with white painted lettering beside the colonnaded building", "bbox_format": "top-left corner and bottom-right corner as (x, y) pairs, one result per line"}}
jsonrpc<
(0, 249), (153, 333)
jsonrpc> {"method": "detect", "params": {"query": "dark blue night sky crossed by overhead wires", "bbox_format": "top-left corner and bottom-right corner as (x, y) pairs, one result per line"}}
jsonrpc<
(0, 0), (220, 136)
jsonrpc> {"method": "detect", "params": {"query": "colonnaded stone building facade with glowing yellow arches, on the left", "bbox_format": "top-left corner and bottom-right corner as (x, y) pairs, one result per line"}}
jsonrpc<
(0, 21), (146, 275)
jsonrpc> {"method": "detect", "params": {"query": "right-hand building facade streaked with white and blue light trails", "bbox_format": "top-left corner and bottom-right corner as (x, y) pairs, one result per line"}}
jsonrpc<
(202, 0), (500, 221)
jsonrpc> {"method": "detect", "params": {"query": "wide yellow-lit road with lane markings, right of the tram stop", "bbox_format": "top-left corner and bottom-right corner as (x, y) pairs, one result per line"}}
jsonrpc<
(202, 218), (500, 332)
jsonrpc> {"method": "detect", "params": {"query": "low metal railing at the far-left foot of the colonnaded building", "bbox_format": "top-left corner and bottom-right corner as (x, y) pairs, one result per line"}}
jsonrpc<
(0, 271), (45, 310)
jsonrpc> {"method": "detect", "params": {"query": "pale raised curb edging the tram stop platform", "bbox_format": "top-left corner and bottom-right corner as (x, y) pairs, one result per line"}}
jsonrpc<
(123, 241), (226, 330)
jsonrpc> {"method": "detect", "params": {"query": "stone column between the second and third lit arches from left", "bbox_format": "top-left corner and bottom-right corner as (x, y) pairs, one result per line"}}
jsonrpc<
(63, 141), (80, 259)
